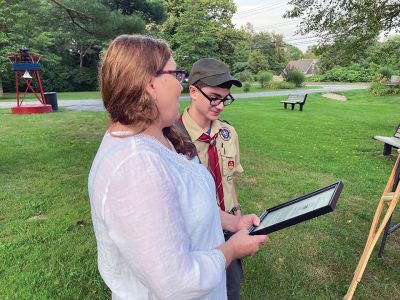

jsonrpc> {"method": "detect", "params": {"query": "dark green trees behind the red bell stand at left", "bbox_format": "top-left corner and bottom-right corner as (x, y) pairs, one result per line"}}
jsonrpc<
(0, 0), (169, 94)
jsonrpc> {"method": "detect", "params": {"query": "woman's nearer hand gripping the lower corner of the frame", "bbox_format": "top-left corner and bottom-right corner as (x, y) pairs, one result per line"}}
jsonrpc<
(218, 229), (268, 267)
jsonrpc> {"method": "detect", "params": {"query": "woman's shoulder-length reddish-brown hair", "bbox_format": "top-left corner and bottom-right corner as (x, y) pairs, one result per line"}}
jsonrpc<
(99, 35), (196, 158)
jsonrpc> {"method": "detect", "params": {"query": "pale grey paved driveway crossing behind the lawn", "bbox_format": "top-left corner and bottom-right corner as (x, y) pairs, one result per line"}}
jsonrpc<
(0, 84), (369, 111)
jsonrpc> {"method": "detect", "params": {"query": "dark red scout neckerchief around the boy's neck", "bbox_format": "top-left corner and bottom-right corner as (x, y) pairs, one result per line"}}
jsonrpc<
(179, 115), (225, 211)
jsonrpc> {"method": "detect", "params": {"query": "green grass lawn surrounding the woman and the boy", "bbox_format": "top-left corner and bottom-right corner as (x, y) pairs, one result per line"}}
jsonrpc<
(0, 91), (400, 300)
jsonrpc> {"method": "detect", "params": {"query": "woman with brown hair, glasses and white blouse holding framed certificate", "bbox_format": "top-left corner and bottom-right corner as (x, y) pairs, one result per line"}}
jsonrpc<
(89, 35), (267, 300)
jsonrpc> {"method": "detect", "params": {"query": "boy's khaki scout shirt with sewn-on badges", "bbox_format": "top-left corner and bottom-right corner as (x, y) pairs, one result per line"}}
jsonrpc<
(182, 108), (243, 212)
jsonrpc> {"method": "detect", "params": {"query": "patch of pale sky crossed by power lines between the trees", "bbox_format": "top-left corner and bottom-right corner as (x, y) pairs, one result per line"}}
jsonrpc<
(232, 0), (316, 52)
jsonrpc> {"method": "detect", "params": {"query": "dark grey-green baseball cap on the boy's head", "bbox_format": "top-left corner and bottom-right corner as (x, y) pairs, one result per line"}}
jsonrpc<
(188, 58), (242, 87)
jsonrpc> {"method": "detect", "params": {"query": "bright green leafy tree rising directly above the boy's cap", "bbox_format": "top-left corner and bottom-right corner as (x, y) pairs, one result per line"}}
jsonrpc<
(166, 0), (240, 70)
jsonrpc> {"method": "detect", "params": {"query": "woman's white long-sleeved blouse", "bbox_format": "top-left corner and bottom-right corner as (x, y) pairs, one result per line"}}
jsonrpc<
(89, 134), (227, 300)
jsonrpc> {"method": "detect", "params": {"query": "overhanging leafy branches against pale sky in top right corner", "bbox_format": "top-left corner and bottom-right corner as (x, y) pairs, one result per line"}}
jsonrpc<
(285, 0), (400, 64)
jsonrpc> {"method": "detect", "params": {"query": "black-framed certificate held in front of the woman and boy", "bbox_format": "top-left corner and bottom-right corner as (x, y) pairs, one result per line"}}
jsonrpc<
(249, 181), (343, 235)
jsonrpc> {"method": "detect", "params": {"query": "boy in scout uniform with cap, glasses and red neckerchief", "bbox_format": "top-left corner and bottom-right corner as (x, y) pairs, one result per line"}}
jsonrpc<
(180, 58), (243, 300)
